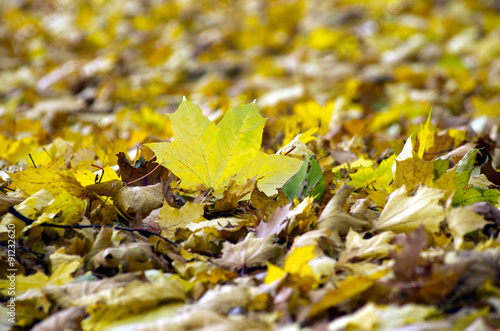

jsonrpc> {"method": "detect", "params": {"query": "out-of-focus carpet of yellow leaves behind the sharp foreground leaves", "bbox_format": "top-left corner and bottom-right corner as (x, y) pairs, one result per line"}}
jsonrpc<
(0, 0), (500, 166)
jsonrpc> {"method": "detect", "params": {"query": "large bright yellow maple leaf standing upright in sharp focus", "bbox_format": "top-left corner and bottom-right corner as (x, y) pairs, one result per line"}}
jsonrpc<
(146, 99), (301, 195)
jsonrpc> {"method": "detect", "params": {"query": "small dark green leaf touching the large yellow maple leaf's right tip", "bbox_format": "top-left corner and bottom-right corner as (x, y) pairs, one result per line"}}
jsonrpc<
(282, 154), (325, 201)
